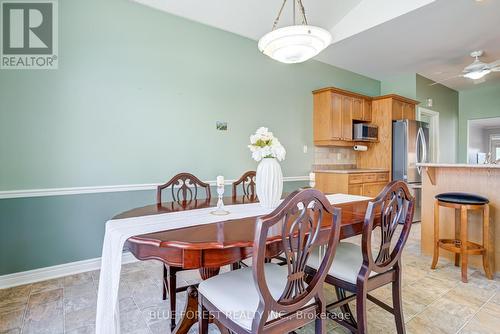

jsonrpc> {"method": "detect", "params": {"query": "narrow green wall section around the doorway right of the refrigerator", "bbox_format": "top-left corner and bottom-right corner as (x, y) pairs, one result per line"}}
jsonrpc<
(416, 74), (459, 163)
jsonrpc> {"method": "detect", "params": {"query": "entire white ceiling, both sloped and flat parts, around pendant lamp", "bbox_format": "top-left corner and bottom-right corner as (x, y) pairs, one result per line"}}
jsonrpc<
(134, 0), (500, 90)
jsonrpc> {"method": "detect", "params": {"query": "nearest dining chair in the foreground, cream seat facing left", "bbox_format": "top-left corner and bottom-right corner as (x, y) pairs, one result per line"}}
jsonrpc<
(198, 189), (341, 334)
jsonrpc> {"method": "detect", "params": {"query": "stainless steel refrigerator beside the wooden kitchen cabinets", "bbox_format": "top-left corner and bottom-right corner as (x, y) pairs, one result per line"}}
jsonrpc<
(392, 119), (430, 222)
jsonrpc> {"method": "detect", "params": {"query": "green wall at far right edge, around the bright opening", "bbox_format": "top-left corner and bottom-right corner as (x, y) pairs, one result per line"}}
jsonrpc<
(459, 82), (500, 163)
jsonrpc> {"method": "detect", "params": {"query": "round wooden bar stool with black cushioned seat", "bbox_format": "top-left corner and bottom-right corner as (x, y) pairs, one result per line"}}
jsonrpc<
(431, 193), (493, 283)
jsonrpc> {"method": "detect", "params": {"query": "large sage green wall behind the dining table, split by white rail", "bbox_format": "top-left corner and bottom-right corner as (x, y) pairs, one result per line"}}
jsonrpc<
(0, 0), (380, 275)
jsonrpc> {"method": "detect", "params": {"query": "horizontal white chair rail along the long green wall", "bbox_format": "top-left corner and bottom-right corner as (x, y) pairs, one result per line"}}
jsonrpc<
(0, 176), (309, 199)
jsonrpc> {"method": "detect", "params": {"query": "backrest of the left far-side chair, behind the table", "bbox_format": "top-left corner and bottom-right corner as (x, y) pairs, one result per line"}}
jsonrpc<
(156, 173), (211, 204)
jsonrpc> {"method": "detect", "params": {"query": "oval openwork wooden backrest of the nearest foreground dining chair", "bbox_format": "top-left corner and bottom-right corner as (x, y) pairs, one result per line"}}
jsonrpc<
(252, 189), (341, 333)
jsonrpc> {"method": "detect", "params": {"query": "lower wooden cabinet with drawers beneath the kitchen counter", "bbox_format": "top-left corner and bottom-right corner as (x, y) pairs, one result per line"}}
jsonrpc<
(316, 172), (389, 197)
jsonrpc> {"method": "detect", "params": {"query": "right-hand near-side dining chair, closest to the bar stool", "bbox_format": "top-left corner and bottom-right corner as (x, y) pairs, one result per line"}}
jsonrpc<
(308, 181), (415, 334)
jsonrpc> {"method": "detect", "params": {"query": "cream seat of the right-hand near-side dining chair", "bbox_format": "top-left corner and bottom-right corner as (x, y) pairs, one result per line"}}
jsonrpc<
(307, 242), (376, 284)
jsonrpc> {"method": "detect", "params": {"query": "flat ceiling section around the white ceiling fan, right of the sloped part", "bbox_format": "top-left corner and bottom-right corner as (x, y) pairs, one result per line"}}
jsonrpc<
(318, 0), (500, 90)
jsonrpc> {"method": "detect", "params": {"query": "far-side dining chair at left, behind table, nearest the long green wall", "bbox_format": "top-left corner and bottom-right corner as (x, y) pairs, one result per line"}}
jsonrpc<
(156, 173), (211, 329)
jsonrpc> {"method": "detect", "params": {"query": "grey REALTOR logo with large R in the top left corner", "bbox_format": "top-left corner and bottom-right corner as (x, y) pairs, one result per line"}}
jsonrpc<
(0, 0), (58, 69)
